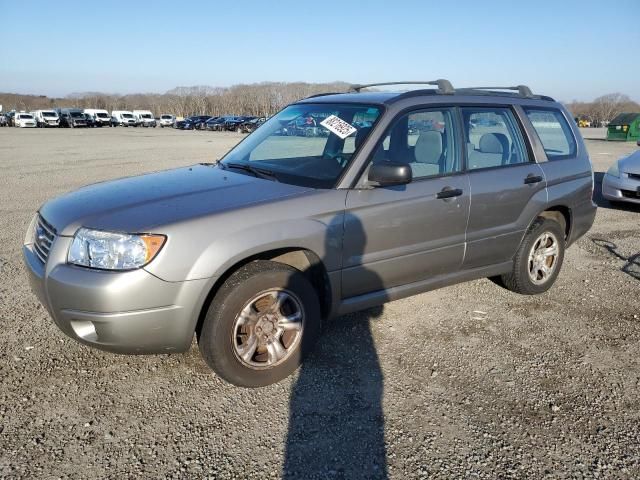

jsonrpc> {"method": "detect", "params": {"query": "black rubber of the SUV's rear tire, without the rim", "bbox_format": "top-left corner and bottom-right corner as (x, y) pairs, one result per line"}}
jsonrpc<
(500, 217), (565, 295)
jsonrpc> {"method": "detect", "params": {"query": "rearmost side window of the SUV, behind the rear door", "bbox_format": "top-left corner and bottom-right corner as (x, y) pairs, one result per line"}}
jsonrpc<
(524, 108), (576, 160)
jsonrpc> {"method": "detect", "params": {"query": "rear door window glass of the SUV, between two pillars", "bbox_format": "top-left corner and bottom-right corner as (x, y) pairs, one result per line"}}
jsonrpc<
(462, 107), (529, 170)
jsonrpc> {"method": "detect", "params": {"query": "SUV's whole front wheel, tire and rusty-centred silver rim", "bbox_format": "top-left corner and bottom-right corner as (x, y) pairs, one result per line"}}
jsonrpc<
(198, 261), (320, 387)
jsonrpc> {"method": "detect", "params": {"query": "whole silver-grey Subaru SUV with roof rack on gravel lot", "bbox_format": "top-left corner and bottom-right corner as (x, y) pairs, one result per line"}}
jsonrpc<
(23, 80), (595, 387)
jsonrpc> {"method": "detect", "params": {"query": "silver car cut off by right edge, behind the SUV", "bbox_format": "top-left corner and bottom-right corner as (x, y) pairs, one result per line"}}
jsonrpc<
(602, 151), (640, 204)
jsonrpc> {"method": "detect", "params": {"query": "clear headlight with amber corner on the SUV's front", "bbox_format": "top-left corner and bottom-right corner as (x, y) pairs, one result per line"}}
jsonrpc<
(67, 228), (167, 270)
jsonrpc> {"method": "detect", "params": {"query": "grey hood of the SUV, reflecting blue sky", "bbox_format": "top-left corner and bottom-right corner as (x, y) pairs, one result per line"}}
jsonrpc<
(40, 165), (310, 236)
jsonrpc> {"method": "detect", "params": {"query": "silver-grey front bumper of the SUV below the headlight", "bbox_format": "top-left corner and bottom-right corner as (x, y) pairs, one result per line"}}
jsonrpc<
(22, 237), (212, 354)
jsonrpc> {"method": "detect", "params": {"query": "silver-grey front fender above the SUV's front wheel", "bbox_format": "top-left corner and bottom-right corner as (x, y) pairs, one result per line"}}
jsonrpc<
(145, 190), (346, 281)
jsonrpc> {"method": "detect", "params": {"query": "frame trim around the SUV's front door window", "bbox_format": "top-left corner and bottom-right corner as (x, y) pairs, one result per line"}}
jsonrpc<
(350, 103), (466, 186)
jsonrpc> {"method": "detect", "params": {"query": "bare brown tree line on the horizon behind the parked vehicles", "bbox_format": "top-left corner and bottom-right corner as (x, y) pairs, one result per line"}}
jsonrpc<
(0, 82), (640, 125)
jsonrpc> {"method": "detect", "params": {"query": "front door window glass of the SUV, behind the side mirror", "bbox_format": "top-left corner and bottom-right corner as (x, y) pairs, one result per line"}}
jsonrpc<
(372, 108), (462, 179)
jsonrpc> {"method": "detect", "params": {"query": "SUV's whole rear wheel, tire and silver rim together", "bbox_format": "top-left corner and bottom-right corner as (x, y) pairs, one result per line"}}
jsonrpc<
(500, 217), (565, 295)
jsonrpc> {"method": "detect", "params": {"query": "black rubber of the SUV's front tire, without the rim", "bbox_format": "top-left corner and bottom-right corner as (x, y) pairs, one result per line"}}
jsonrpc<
(198, 261), (321, 387)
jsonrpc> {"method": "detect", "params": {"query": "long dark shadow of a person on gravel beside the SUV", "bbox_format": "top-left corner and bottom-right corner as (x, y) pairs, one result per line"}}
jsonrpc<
(282, 215), (388, 479)
